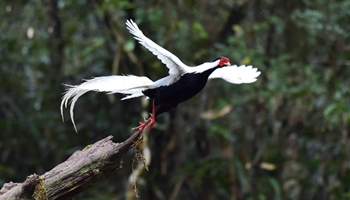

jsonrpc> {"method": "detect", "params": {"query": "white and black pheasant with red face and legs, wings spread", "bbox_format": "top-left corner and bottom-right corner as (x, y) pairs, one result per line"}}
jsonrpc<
(61, 20), (260, 131)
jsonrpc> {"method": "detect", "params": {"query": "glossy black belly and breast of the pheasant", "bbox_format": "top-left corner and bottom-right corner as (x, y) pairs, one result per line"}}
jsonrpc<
(143, 69), (214, 115)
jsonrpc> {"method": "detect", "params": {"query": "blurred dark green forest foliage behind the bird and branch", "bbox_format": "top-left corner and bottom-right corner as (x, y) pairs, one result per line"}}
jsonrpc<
(0, 0), (350, 199)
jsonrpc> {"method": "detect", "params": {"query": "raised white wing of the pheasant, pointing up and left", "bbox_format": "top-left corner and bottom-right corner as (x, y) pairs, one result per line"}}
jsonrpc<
(125, 19), (188, 75)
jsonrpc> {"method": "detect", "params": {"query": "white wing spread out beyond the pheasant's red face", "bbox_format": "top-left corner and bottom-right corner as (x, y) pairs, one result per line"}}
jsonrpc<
(208, 65), (261, 84)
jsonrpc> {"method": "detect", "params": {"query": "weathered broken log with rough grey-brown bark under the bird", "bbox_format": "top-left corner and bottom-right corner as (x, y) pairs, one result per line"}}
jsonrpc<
(0, 131), (142, 200)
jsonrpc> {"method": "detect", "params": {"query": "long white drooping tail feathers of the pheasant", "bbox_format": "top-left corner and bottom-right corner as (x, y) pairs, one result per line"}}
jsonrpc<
(61, 75), (153, 131)
